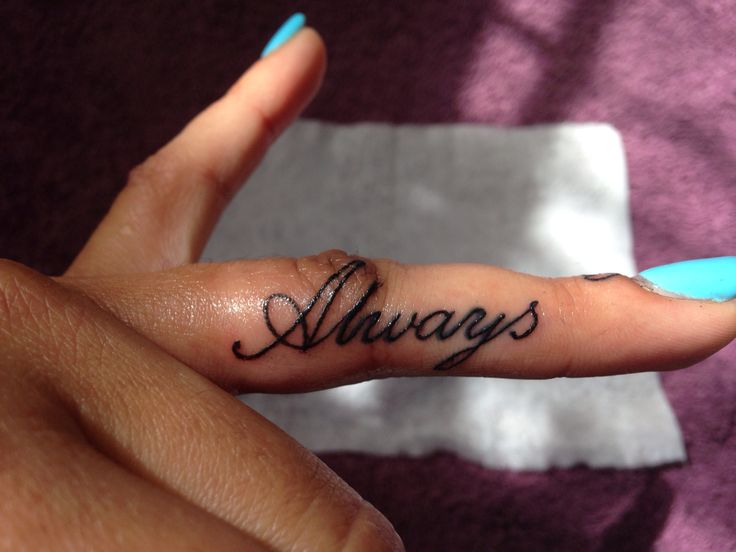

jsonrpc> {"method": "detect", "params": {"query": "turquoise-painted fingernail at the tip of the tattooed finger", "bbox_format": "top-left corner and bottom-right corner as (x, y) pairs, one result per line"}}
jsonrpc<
(635, 257), (736, 301)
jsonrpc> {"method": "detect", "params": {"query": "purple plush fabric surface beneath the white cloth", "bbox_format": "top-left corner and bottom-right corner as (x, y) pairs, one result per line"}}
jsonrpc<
(0, 0), (736, 551)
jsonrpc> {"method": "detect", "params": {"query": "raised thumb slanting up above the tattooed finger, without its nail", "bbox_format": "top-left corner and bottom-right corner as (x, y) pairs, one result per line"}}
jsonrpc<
(67, 23), (326, 276)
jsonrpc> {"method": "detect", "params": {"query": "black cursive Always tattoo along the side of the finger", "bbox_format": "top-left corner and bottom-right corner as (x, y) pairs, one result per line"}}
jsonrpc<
(232, 260), (539, 370)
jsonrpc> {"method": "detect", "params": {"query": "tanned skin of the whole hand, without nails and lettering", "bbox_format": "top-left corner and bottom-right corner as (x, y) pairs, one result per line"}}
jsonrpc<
(0, 29), (736, 551)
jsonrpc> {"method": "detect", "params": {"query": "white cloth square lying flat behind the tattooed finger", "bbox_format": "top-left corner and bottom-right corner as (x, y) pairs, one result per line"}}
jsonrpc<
(204, 121), (685, 469)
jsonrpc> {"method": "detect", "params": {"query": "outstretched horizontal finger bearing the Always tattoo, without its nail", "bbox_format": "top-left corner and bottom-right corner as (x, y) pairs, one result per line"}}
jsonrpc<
(70, 251), (736, 392)
